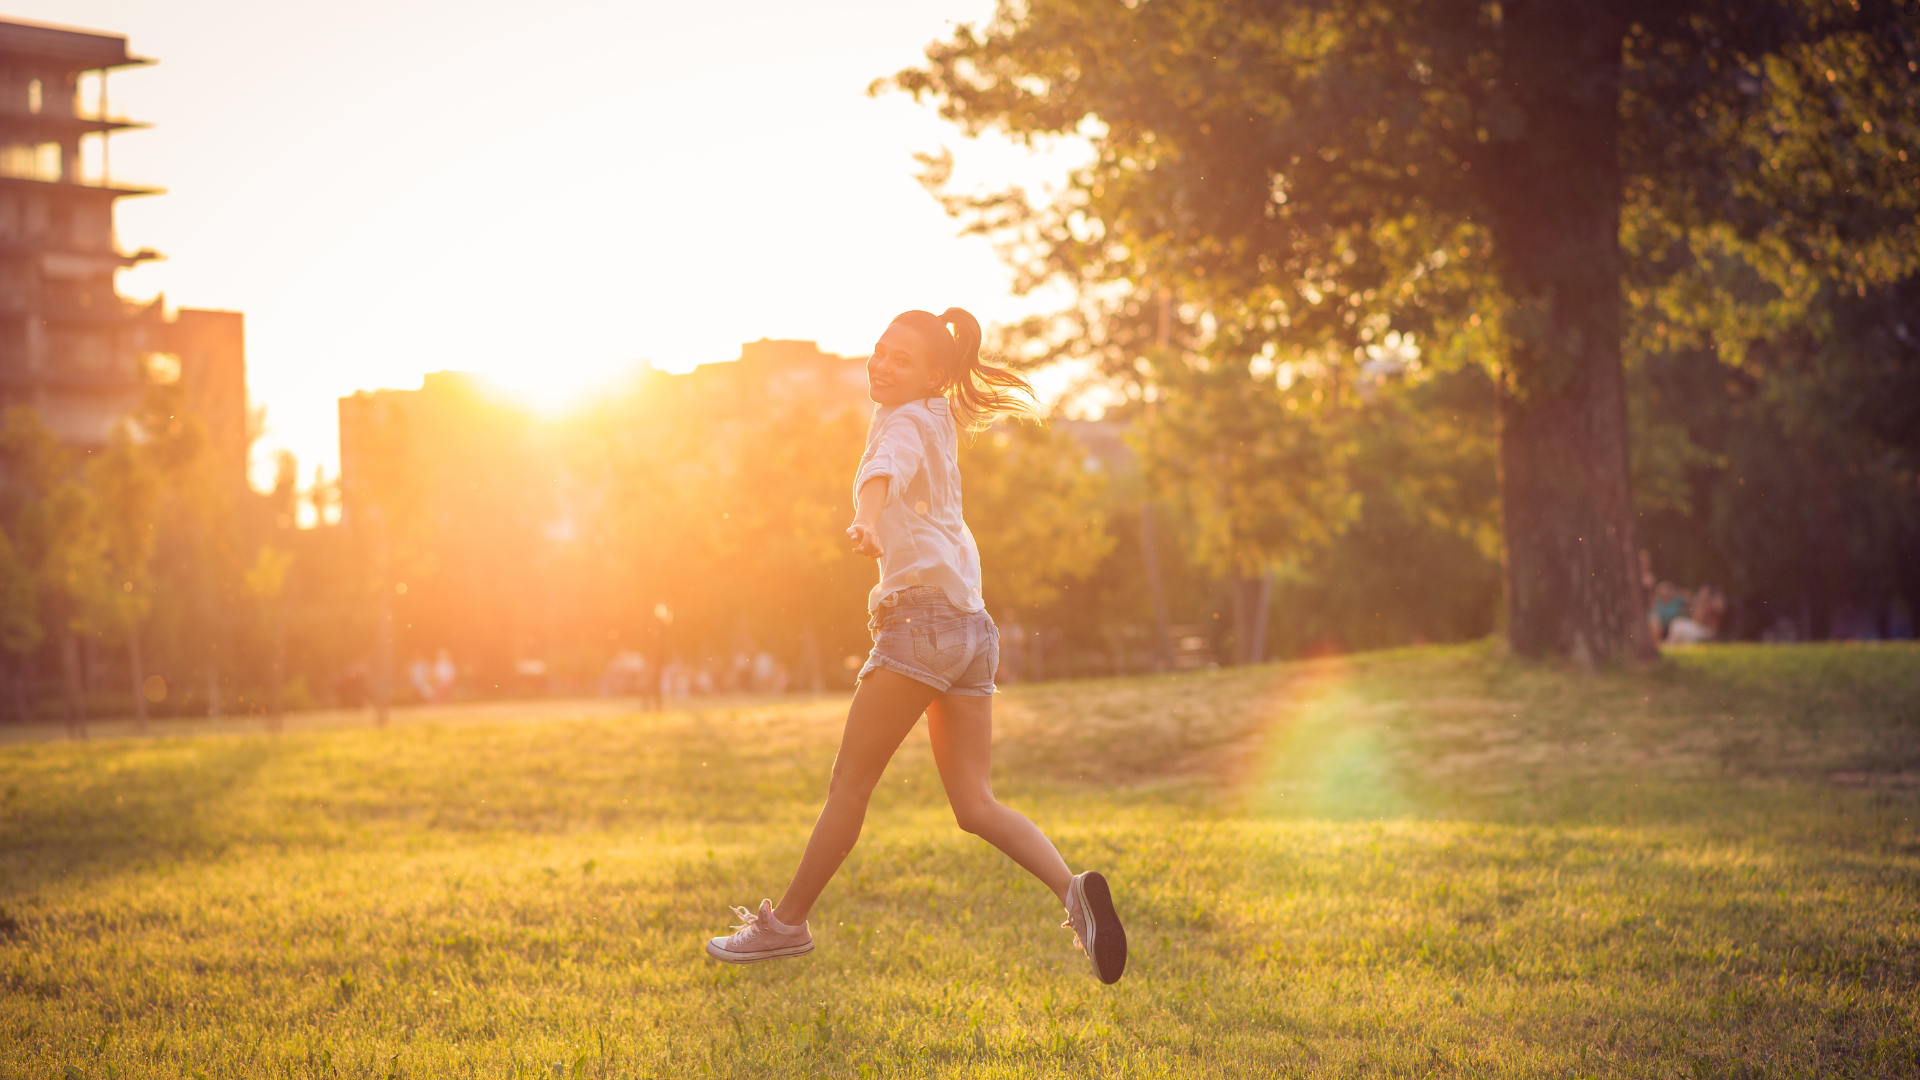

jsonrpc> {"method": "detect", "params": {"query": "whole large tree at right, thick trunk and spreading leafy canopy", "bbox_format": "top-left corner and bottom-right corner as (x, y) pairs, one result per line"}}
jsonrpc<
(893, 0), (1920, 661)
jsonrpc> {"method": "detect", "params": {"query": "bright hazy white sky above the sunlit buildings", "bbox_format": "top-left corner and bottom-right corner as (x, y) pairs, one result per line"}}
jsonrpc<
(22, 0), (1082, 471)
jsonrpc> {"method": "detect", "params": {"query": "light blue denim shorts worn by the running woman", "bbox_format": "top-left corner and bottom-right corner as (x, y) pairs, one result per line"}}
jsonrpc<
(860, 584), (1000, 698)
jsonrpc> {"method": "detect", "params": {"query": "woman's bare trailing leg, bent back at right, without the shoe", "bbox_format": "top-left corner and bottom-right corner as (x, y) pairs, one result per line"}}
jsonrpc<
(927, 694), (1073, 905)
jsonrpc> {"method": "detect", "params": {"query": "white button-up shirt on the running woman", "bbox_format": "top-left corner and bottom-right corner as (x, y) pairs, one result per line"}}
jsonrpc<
(852, 398), (987, 611)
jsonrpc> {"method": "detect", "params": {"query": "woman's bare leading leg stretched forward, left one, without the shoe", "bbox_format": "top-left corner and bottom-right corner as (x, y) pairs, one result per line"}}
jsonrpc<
(774, 669), (936, 926)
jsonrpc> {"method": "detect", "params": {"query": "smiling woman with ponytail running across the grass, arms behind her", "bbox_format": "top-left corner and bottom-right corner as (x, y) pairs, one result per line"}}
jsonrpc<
(707, 307), (1127, 982)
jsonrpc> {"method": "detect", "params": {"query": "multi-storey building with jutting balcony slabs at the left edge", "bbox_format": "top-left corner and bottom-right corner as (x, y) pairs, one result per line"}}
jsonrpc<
(0, 21), (248, 480)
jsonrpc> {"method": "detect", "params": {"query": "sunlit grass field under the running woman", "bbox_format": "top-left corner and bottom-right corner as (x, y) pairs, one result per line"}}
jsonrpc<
(0, 646), (1920, 1078)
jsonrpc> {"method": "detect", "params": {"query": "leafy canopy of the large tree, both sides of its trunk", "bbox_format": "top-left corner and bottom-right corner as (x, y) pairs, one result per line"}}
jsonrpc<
(898, 0), (1920, 367)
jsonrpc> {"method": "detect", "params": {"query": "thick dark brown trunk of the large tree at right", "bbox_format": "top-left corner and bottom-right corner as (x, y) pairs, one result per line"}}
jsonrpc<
(1475, 0), (1655, 665)
